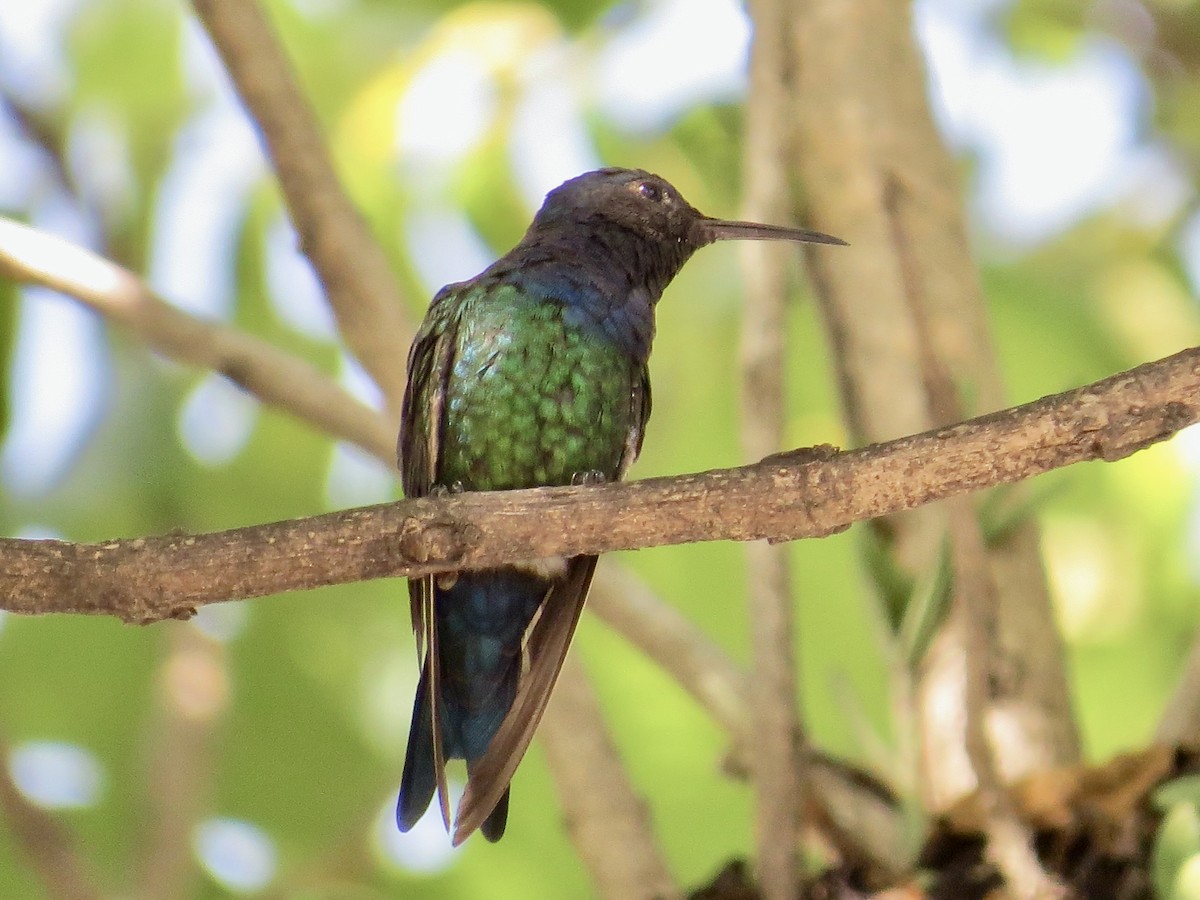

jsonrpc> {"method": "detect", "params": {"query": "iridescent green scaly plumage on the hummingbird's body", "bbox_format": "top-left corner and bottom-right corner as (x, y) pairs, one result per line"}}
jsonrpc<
(436, 286), (646, 491)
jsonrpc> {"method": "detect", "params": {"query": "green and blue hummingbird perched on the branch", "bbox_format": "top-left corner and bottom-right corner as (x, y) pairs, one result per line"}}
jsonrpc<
(396, 168), (845, 845)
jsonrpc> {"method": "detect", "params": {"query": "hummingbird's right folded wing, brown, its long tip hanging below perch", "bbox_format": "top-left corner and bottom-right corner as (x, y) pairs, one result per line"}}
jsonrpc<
(454, 366), (650, 846)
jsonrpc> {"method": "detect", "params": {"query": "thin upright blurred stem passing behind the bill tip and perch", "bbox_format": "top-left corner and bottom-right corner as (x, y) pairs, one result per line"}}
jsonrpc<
(740, 0), (804, 900)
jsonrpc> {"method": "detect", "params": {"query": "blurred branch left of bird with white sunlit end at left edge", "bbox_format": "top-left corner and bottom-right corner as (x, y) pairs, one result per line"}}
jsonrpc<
(0, 217), (395, 458)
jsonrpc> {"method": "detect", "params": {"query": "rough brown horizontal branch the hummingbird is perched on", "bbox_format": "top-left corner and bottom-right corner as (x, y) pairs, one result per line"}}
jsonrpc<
(0, 348), (1200, 622)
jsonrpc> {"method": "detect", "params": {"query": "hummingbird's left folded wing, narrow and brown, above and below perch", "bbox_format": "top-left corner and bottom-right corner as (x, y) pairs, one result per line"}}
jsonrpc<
(396, 284), (458, 830)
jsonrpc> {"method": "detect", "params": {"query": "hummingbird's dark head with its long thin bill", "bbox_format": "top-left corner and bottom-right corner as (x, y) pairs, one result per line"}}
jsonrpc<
(530, 168), (845, 256)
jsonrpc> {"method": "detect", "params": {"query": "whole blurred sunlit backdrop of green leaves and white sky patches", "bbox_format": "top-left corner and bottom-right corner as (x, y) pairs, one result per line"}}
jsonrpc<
(0, 0), (1200, 898)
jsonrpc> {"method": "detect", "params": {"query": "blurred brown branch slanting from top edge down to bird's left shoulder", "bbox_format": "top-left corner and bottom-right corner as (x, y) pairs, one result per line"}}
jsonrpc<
(193, 0), (413, 412)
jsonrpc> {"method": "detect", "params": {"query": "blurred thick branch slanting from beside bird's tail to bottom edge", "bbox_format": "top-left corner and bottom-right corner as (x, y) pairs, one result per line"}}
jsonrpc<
(538, 656), (679, 900)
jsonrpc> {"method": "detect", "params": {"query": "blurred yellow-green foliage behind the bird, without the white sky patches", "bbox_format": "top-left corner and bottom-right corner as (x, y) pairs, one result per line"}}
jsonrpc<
(0, 0), (1200, 900)
